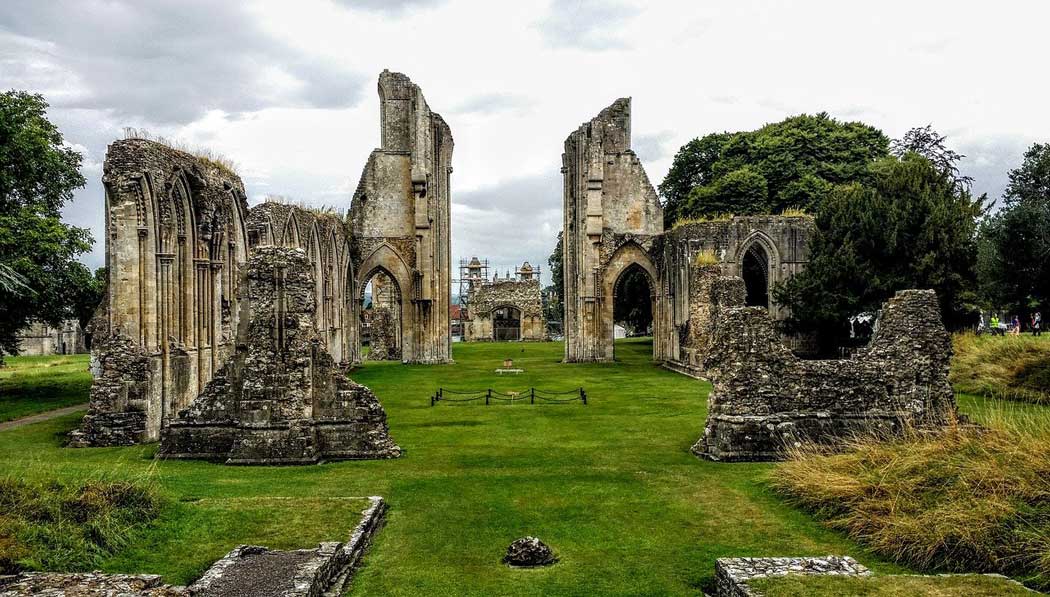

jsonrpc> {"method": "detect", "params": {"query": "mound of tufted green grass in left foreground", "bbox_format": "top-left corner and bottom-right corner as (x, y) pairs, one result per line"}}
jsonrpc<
(0, 477), (161, 574)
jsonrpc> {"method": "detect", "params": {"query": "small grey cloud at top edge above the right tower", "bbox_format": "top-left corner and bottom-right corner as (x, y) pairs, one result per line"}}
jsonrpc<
(536, 0), (638, 50)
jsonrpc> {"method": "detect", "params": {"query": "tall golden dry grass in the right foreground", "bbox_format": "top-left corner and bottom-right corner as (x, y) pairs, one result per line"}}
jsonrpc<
(772, 425), (1050, 588)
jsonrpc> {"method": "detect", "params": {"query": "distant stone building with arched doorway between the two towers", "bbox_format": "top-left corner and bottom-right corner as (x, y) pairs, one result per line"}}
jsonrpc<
(464, 257), (546, 342)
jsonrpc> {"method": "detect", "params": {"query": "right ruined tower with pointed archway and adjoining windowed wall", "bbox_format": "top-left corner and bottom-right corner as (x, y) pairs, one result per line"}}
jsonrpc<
(562, 99), (814, 367)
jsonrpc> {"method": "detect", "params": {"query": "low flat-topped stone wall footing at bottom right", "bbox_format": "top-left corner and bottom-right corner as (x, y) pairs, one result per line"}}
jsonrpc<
(715, 555), (872, 597)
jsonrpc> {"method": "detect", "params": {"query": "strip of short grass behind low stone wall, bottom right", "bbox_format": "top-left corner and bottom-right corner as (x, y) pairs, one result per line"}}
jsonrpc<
(749, 574), (1032, 597)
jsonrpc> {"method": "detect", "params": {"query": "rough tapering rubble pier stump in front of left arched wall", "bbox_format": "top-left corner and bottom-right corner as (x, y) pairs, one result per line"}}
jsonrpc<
(158, 247), (401, 465)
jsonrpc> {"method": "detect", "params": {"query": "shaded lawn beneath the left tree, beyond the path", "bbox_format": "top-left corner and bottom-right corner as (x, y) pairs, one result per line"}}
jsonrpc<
(0, 355), (91, 423)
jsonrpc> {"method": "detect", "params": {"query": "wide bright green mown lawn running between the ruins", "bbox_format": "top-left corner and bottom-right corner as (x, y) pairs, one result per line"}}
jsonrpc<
(0, 340), (1046, 595)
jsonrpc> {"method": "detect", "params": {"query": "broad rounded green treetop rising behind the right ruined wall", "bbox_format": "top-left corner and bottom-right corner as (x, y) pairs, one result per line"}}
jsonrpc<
(659, 112), (889, 223)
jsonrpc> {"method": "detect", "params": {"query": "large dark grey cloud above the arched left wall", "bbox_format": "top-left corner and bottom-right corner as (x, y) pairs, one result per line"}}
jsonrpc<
(0, 0), (365, 125)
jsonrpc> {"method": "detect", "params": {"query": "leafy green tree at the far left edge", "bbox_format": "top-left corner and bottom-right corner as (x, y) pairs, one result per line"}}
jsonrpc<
(0, 91), (91, 354)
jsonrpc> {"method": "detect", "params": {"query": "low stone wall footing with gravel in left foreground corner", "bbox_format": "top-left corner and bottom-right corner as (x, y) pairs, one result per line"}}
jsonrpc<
(0, 496), (386, 597)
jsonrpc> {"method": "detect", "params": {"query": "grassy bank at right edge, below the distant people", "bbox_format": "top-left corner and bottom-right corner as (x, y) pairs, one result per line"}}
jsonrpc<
(950, 334), (1050, 404)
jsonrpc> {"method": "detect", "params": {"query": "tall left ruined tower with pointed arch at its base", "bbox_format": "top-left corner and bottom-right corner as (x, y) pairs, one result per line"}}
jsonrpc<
(351, 70), (453, 363)
